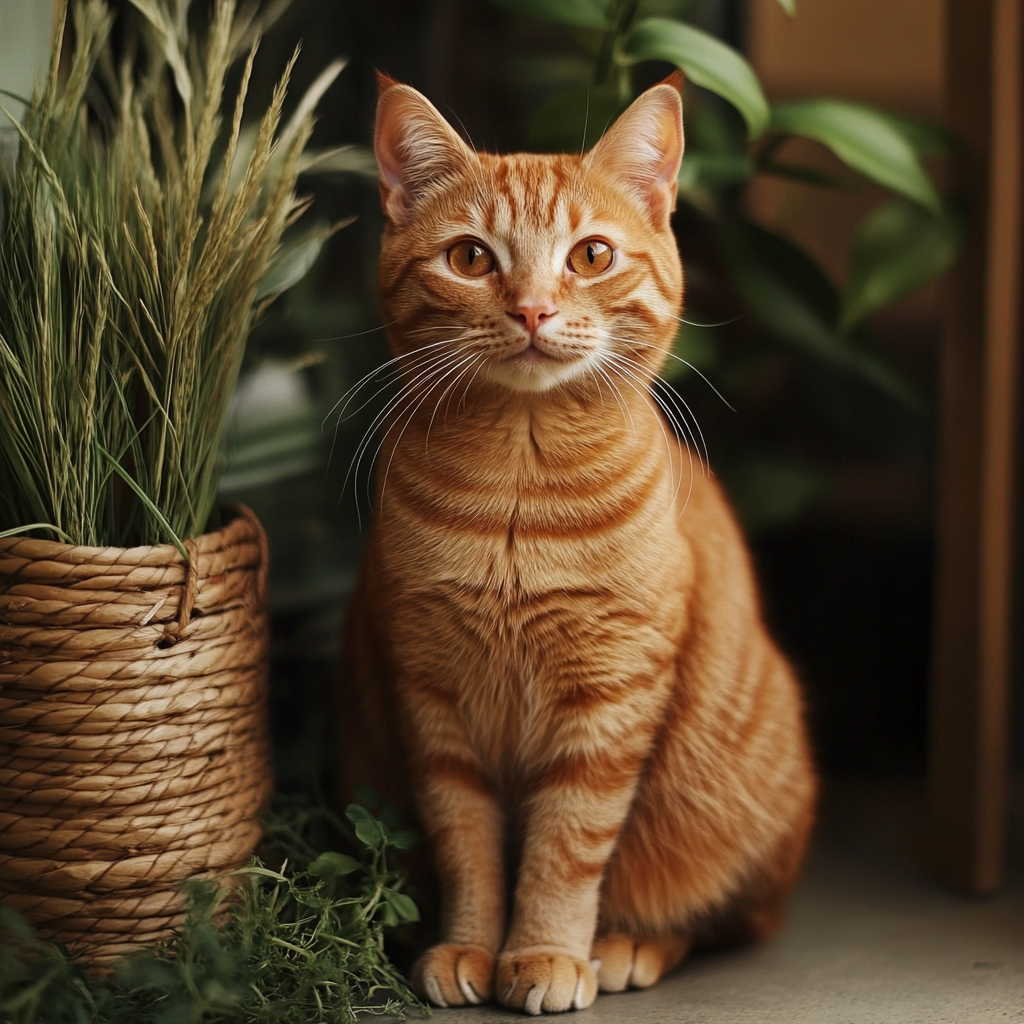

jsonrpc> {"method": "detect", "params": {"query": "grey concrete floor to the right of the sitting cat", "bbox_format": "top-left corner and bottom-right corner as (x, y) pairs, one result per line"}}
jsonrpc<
(423, 785), (1024, 1024)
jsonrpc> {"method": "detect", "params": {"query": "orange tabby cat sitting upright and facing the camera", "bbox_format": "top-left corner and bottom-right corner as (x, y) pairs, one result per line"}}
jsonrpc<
(341, 77), (815, 1014)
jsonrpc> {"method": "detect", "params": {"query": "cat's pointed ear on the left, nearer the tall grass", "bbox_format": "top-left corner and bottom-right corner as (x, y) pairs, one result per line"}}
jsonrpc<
(374, 73), (476, 223)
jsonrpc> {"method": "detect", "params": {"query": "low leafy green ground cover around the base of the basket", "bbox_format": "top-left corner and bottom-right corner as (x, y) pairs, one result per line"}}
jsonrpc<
(0, 800), (426, 1024)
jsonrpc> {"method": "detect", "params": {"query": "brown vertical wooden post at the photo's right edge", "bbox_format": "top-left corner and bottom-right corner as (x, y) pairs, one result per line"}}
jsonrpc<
(926, 0), (1024, 893)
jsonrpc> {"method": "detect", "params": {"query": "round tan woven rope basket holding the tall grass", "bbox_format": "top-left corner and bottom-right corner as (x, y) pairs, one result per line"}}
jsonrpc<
(0, 508), (271, 966)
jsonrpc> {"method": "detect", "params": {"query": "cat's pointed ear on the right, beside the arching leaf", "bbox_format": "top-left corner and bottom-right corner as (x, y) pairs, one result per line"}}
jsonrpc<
(584, 72), (683, 224)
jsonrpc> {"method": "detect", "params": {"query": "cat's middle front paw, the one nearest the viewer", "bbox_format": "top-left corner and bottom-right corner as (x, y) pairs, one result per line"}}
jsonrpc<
(495, 949), (597, 1014)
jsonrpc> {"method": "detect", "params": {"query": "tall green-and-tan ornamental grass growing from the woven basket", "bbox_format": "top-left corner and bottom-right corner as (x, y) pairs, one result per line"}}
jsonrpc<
(0, 0), (341, 557)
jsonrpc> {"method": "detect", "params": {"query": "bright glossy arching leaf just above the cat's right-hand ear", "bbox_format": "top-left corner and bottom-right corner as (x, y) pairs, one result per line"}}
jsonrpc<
(625, 17), (769, 138)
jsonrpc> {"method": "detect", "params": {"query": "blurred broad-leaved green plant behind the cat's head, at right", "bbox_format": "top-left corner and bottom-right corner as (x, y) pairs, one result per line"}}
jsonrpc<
(493, 0), (959, 530)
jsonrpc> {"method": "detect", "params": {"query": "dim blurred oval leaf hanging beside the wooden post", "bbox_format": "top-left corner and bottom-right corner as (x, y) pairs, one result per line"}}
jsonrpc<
(840, 199), (957, 331)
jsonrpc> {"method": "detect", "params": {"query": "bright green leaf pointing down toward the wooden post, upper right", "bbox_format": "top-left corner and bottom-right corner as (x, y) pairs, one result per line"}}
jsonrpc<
(771, 99), (941, 216)
